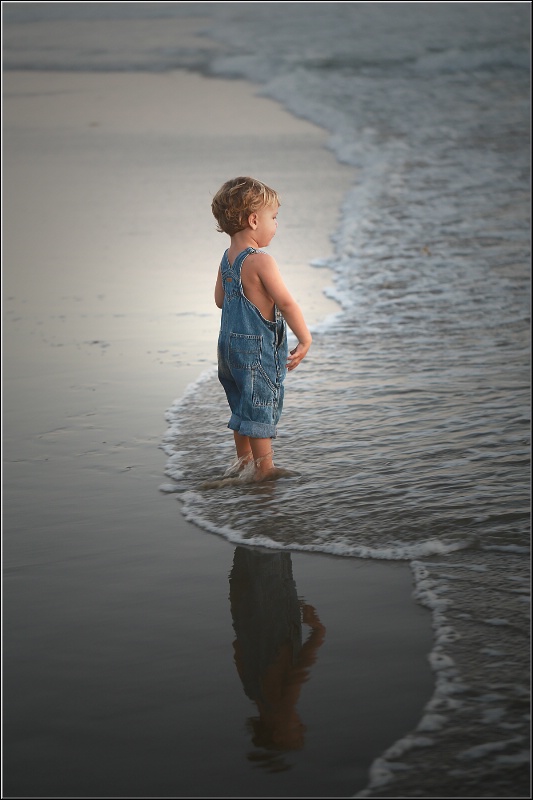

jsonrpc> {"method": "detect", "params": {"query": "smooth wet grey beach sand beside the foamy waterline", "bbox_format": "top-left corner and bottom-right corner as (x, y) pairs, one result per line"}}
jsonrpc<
(3, 72), (433, 797)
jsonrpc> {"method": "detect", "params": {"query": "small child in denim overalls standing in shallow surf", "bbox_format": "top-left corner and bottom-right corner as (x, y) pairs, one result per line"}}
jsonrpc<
(211, 177), (311, 480)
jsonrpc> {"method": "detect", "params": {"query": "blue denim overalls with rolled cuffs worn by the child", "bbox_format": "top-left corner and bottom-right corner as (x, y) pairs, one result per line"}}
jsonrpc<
(218, 247), (287, 439)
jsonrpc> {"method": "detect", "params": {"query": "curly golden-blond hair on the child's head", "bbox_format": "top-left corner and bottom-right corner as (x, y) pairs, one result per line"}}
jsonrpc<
(211, 178), (281, 236)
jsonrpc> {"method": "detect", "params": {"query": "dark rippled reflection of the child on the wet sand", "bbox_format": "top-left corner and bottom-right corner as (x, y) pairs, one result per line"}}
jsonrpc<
(230, 547), (326, 770)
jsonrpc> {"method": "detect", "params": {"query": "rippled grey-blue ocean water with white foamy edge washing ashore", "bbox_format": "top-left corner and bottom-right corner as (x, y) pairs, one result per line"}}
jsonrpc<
(4, 3), (530, 797)
